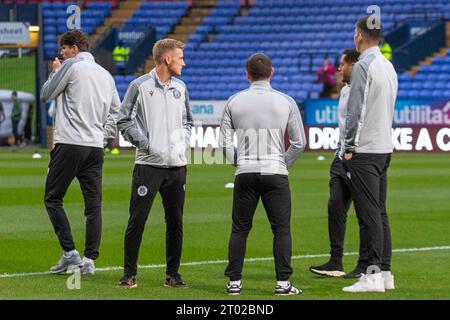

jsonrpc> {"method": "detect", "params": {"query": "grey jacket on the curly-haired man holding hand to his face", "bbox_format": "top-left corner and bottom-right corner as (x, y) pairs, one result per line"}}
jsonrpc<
(41, 52), (120, 148)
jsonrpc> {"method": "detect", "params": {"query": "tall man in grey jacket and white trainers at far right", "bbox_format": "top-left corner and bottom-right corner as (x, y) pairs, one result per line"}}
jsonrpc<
(343, 17), (398, 292)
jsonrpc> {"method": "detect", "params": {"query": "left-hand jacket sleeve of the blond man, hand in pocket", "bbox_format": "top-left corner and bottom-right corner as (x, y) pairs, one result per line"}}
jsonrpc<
(117, 82), (149, 149)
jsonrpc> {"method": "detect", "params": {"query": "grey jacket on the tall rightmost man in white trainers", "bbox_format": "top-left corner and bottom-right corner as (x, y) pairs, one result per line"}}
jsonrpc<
(345, 47), (398, 154)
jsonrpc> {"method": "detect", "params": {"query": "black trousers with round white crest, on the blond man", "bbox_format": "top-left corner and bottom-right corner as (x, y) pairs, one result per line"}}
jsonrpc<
(124, 164), (186, 276)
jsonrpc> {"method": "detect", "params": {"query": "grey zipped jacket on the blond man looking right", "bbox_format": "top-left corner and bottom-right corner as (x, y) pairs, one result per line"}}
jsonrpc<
(117, 69), (193, 167)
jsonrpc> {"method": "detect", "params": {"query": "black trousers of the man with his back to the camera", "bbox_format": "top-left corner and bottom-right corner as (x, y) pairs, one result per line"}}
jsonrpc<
(225, 173), (292, 281)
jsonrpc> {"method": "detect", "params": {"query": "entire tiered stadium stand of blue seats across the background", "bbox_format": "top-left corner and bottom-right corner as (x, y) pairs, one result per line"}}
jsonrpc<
(25, 0), (450, 101)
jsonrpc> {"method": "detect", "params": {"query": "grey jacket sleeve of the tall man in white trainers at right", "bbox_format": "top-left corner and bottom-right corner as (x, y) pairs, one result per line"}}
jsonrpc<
(345, 61), (370, 152)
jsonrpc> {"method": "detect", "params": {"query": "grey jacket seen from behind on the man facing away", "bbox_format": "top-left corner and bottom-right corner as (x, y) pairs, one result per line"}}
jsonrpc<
(219, 81), (306, 175)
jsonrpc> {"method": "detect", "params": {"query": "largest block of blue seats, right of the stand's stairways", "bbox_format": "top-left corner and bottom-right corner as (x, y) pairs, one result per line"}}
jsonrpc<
(179, 0), (446, 101)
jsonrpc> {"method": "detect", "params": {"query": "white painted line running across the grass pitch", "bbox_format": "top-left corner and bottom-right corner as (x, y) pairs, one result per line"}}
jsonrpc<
(0, 246), (450, 278)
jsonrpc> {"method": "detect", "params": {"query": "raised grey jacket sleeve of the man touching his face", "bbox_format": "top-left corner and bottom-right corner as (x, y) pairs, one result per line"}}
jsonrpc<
(41, 59), (75, 103)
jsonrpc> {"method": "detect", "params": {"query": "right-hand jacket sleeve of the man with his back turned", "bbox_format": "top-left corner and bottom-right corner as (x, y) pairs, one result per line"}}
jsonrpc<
(284, 101), (306, 168)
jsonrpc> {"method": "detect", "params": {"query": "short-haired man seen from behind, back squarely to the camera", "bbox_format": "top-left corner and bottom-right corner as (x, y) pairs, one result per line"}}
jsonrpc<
(219, 54), (306, 295)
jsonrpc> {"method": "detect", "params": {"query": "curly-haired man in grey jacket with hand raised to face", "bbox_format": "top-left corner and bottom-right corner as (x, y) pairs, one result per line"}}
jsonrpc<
(41, 30), (120, 274)
